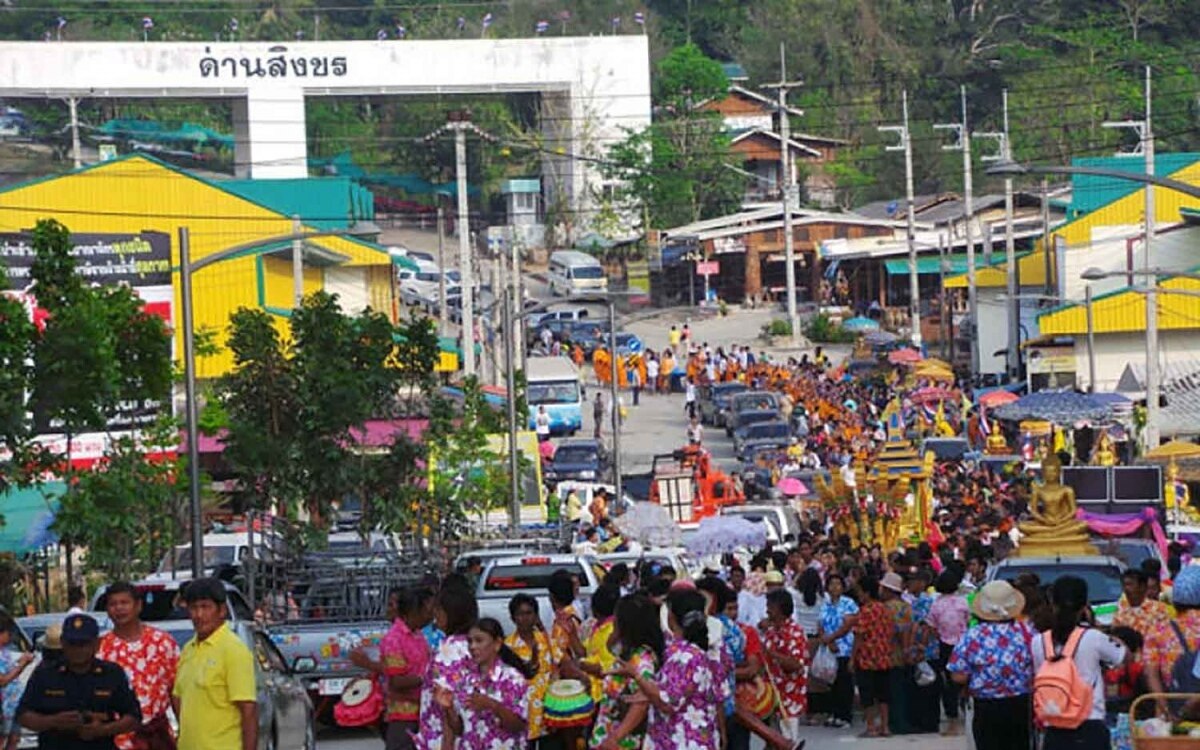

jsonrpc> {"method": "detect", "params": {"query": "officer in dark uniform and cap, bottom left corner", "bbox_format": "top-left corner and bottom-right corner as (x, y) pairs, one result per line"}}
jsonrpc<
(17, 614), (142, 750)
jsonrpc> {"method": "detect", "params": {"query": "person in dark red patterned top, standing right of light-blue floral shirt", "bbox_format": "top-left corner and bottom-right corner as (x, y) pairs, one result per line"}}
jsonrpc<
(852, 576), (896, 737)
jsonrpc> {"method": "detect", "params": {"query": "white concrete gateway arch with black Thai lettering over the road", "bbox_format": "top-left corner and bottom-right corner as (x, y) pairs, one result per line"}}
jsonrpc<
(0, 35), (650, 225)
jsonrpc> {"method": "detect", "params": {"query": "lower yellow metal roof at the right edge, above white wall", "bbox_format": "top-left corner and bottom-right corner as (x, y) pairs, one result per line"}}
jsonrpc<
(1038, 277), (1200, 336)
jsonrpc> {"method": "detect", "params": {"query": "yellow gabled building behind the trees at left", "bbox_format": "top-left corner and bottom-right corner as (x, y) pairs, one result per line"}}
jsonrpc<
(0, 155), (396, 378)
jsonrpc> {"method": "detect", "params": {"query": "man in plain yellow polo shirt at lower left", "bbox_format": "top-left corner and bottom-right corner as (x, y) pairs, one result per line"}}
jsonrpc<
(172, 578), (258, 750)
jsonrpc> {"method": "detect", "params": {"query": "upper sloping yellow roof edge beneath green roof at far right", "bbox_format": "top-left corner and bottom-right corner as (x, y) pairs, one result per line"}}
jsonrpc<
(946, 162), (1200, 289)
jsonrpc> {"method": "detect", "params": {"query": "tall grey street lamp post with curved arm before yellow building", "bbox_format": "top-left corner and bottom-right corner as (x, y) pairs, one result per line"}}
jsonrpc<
(179, 227), (369, 580)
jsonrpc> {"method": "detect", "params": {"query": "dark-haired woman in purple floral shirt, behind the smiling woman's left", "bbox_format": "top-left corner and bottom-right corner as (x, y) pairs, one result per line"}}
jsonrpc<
(413, 585), (479, 750)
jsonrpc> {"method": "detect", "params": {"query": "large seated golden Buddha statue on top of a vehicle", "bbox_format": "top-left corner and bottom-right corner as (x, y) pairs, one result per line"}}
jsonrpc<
(1016, 454), (1097, 557)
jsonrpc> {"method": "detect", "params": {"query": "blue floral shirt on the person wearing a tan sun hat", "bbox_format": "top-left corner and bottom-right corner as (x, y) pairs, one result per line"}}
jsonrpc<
(946, 623), (1033, 698)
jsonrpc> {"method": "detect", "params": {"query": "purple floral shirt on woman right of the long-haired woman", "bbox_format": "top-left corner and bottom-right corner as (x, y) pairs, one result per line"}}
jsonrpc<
(646, 640), (730, 750)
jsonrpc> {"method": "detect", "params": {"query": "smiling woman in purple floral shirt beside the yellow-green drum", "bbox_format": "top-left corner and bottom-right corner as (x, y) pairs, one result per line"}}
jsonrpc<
(436, 617), (532, 750)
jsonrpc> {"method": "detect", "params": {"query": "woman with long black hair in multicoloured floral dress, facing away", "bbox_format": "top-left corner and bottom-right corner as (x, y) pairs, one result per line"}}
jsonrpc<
(588, 594), (666, 750)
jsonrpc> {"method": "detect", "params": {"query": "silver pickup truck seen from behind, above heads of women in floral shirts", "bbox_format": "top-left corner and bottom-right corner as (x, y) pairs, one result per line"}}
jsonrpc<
(475, 553), (604, 631)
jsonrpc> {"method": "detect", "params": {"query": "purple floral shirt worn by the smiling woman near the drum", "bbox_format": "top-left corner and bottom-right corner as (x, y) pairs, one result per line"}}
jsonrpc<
(454, 661), (529, 750)
